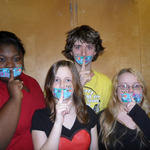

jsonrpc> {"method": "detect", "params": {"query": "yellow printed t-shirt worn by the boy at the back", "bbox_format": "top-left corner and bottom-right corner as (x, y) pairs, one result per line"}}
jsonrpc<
(83, 70), (112, 113)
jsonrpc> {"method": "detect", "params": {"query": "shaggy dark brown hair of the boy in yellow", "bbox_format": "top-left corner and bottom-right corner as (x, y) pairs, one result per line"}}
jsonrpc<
(62, 25), (104, 61)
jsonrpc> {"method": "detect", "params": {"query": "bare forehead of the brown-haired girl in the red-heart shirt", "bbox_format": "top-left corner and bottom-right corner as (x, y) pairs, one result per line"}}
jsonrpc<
(56, 67), (72, 78)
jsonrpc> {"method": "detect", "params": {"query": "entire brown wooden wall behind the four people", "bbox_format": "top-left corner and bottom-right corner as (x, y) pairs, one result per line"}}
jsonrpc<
(0, 0), (150, 90)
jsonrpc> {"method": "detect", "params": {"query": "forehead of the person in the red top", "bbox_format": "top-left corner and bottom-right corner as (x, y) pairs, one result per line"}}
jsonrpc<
(0, 45), (18, 57)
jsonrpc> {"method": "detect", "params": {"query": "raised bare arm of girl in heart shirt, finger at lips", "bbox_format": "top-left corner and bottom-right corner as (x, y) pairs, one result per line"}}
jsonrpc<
(32, 90), (70, 150)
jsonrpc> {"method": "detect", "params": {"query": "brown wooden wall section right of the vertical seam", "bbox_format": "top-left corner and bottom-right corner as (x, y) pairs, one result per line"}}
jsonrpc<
(77, 0), (150, 90)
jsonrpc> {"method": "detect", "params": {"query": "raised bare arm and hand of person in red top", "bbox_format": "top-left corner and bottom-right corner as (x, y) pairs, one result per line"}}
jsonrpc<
(0, 72), (23, 150)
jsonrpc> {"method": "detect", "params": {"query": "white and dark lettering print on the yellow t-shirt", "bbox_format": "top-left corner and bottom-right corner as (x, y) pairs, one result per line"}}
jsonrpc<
(83, 86), (101, 113)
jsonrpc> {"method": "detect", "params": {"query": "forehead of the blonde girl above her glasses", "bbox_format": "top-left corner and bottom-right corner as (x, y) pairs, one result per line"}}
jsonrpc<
(118, 72), (138, 84)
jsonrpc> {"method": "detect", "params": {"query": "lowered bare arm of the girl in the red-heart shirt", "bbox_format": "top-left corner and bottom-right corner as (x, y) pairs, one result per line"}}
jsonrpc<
(90, 126), (98, 150)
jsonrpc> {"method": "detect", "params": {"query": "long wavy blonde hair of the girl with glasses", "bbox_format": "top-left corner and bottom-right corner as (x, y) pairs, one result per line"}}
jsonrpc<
(99, 68), (150, 149)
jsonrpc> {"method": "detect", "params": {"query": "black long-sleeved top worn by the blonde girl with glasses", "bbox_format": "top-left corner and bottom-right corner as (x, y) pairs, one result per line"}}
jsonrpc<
(98, 104), (150, 150)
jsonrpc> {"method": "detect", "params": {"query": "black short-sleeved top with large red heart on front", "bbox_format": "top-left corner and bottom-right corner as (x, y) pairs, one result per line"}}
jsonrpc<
(31, 106), (97, 150)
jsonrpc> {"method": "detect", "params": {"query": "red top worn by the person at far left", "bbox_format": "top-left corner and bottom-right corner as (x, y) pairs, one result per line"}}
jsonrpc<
(0, 73), (45, 150)
